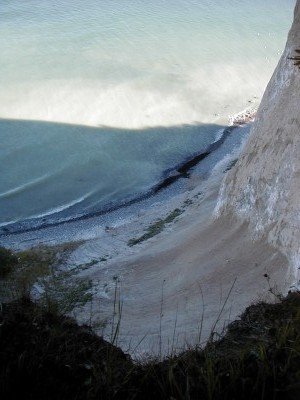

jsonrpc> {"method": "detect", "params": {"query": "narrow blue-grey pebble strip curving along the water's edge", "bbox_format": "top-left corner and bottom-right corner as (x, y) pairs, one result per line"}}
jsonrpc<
(0, 119), (250, 249)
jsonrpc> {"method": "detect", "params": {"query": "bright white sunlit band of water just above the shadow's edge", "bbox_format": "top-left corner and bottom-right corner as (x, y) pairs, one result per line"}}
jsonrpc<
(0, 60), (271, 129)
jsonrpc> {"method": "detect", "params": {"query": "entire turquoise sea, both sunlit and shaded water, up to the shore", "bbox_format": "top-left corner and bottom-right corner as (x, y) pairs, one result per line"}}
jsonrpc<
(0, 0), (295, 230)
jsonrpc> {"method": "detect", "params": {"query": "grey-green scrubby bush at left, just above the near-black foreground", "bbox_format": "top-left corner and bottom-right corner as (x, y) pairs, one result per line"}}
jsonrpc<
(0, 243), (93, 314)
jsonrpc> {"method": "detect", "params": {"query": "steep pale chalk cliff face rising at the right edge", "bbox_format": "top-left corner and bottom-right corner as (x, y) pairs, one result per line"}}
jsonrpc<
(217, 0), (300, 285)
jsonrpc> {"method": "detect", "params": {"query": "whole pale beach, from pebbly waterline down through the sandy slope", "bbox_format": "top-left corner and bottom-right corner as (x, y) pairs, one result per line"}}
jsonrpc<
(0, 108), (288, 359)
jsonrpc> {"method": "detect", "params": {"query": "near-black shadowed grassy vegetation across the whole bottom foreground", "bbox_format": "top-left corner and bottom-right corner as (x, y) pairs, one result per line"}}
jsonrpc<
(0, 293), (300, 400)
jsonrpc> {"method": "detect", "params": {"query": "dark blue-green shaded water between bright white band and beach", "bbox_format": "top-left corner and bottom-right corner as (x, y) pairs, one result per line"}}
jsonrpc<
(0, 119), (232, 235)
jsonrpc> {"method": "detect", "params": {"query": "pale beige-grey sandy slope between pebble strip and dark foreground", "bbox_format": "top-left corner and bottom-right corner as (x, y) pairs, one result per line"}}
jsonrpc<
(69, 170), (288, 358)
